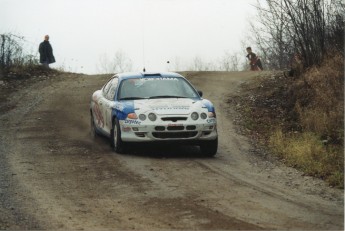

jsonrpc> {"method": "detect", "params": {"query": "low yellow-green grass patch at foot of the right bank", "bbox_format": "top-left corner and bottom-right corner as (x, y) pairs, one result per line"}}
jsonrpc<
(269, 130), (344, 188)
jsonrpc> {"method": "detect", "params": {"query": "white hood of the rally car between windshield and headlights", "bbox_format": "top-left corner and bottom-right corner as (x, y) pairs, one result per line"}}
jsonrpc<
(134, 98), (208, 115)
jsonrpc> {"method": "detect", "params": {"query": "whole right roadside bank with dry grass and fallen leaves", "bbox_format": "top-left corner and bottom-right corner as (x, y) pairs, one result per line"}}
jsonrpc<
(228, 56), (344, 188)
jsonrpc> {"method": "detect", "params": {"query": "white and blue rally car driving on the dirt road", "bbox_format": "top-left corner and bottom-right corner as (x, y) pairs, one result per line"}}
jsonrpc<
(90, 73), (218, 156)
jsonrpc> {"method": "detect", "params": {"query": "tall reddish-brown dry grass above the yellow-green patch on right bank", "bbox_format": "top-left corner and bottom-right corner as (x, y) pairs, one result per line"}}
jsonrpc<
(296, 55), (344, 143)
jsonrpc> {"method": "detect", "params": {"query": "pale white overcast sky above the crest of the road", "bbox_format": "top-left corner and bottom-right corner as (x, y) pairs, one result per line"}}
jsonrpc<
(0, 0), (256, 74)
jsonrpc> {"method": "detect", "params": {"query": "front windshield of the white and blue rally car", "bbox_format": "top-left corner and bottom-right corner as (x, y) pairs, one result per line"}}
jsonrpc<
(118, 77), (199, 100)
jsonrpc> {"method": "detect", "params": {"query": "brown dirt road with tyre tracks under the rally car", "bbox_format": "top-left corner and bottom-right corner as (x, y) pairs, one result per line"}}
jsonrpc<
(0, 72), (344, 230)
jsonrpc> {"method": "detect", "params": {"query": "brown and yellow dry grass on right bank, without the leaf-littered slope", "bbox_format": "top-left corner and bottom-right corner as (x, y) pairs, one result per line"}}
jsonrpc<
(269, 55), (344, 188)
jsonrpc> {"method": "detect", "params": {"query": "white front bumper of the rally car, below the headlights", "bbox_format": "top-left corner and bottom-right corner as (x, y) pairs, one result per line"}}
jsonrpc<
(119, 119), (218, 143)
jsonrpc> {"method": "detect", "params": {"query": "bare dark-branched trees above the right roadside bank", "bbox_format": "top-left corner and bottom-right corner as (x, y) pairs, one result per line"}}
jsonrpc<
(251, 0), (345, 69)
